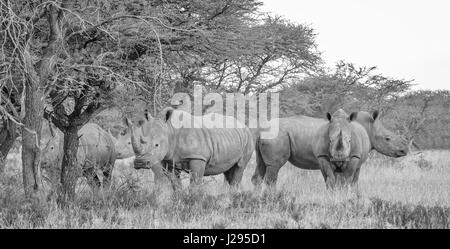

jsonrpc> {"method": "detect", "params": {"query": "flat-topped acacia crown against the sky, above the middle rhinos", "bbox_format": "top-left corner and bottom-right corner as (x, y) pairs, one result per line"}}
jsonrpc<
(205, 16), (321, 93)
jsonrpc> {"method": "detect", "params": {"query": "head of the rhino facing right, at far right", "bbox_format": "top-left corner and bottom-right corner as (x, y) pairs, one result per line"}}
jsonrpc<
(350, 111), (410, 157)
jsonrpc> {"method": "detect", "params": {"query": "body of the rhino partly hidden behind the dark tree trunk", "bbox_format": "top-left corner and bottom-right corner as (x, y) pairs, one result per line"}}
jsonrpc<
(41, 123), (116, 190)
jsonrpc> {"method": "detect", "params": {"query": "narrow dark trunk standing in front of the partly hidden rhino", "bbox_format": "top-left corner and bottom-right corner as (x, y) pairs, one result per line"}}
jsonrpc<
(59, 126), (81, 204)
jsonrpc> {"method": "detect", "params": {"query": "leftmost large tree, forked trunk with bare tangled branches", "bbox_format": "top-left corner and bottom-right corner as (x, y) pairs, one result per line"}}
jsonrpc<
(1, 0), (70, 197)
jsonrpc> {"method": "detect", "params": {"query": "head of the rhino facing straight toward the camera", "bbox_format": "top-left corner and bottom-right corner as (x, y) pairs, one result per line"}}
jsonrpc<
(327, 109), (352, 167)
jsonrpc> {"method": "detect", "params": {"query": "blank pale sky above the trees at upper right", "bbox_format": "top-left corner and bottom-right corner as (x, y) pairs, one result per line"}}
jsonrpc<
(262, 0), (450, 89)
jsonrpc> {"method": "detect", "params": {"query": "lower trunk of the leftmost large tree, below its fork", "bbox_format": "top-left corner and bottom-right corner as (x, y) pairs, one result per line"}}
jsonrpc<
(22, 83), (44, 198)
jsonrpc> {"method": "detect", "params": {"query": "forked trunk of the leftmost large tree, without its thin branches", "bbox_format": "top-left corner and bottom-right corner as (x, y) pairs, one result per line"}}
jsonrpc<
(22, 2), (64, 200)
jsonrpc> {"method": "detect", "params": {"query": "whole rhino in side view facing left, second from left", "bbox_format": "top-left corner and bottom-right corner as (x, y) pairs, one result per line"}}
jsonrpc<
(125, 107), (254, 186)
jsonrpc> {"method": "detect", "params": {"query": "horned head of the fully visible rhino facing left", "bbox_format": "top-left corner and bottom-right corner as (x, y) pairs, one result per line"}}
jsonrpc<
(124, 107), (174, 169)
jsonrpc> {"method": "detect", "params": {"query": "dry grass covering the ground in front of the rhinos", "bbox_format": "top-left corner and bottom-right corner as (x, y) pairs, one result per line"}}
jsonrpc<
(0, 151), (450, 228)
